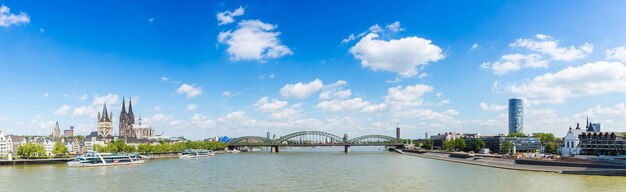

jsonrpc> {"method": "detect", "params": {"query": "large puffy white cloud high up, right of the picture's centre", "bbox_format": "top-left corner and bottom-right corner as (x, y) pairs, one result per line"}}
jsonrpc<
(350, 33), (444, 77)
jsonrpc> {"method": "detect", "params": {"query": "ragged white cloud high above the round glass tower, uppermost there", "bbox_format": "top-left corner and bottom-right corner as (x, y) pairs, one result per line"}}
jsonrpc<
(480, 34), (593, 75)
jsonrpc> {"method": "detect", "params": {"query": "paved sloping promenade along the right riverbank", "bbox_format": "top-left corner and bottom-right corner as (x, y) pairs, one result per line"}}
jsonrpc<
(402, 152), (626, 176)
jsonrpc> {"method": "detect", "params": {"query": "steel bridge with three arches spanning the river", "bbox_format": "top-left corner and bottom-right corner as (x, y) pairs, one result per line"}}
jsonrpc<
(226, 131), (404, 153)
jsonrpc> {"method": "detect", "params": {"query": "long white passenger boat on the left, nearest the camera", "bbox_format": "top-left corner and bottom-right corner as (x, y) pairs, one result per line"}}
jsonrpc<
(67, 151), (144, 167)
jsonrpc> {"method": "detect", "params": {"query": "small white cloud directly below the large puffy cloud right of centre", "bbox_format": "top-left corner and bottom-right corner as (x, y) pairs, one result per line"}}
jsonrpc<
(385, 84), (433, 108)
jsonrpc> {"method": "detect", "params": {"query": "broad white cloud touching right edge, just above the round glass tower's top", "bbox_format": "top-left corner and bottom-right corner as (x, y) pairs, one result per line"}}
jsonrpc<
(507, 61), (626, 103)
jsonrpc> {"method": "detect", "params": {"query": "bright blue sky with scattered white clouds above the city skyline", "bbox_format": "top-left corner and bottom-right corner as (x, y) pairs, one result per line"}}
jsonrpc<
(0, 0), (626, 139)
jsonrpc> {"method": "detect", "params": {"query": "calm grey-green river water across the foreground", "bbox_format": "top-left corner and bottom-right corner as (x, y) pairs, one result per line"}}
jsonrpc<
(0, 147), (626, 191)
